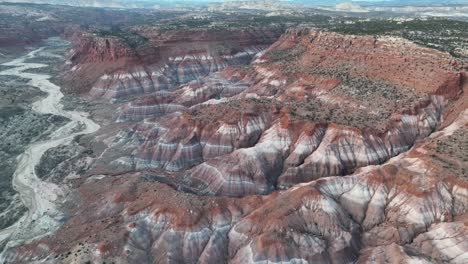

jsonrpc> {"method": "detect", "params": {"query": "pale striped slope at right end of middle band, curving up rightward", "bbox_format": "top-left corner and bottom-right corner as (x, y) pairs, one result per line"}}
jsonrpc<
(279, 97), (443, 189)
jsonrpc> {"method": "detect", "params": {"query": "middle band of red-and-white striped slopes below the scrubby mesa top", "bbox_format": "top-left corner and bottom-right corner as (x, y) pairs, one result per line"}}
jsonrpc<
(111, 96), (444, 196)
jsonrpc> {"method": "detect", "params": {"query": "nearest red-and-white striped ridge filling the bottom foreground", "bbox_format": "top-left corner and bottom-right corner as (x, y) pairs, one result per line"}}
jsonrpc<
(4, 108), (468, 263)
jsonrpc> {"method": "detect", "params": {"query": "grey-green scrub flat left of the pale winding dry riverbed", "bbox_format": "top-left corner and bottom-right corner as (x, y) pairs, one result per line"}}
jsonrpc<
(0, 38), (72, 229)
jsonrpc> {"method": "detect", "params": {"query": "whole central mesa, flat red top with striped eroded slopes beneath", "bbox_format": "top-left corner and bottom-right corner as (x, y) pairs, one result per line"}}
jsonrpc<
(87, 30), (465, 196)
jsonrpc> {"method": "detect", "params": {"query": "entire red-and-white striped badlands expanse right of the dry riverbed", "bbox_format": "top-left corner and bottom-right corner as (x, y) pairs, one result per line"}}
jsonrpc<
(6, 28), (468, 264)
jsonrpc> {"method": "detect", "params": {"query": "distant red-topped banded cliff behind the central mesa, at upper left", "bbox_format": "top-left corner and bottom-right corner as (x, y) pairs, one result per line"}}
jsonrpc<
(67, 26), (284, 100)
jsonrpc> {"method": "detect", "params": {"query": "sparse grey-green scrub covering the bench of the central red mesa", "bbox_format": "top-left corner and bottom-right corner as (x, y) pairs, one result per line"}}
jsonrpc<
(265, 47), (427, 131)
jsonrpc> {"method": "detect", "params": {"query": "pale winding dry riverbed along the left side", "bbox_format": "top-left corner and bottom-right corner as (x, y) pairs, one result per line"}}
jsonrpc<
(0, 45), (99, 263)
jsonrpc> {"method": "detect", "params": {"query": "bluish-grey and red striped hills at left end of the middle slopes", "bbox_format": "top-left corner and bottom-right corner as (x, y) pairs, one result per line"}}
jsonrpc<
(115, 100), (274, 171)
